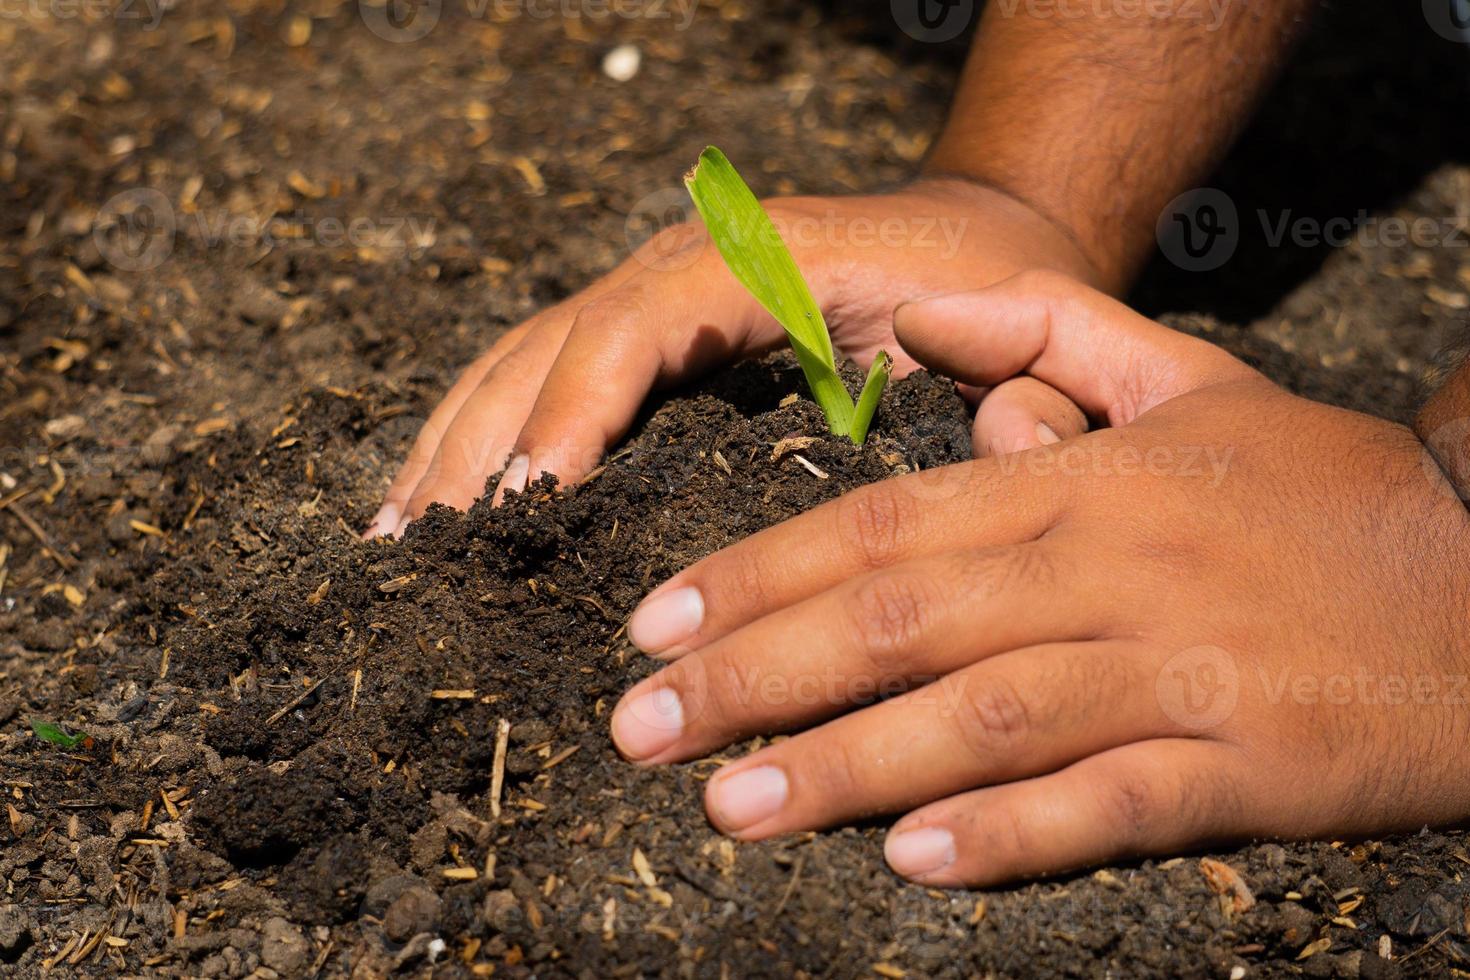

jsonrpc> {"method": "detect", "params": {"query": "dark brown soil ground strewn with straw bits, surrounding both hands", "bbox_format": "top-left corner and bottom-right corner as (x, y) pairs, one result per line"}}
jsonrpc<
(0, 0), (1470, 977)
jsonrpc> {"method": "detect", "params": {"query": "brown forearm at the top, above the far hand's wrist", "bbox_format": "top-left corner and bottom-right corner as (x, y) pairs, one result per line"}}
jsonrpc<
(925, 0), (1316, 291)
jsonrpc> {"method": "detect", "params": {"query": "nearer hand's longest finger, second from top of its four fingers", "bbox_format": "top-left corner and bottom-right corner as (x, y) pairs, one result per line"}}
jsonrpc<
(612, 542), (1116, 764)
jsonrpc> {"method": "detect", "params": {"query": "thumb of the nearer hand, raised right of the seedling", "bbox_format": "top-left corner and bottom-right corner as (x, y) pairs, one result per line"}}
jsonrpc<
(894, 270), (1255, 426)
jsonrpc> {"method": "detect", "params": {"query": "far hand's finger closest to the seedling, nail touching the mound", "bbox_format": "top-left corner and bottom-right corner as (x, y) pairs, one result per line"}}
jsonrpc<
(497, 264), (779, 497)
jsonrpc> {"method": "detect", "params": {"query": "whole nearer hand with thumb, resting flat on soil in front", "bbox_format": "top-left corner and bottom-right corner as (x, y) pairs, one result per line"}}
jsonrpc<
(612, 273), (1470, 886)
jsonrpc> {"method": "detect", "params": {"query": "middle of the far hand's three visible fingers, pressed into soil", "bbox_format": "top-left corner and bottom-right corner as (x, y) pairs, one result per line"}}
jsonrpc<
(397, 318), (570, 535)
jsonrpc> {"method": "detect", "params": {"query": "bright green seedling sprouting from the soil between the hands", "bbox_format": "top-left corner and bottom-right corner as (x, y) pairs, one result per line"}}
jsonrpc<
(684, 147), (894, 445)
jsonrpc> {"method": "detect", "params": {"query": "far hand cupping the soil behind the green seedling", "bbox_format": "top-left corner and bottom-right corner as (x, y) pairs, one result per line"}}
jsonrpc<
(368, 179), (1094, 536)
